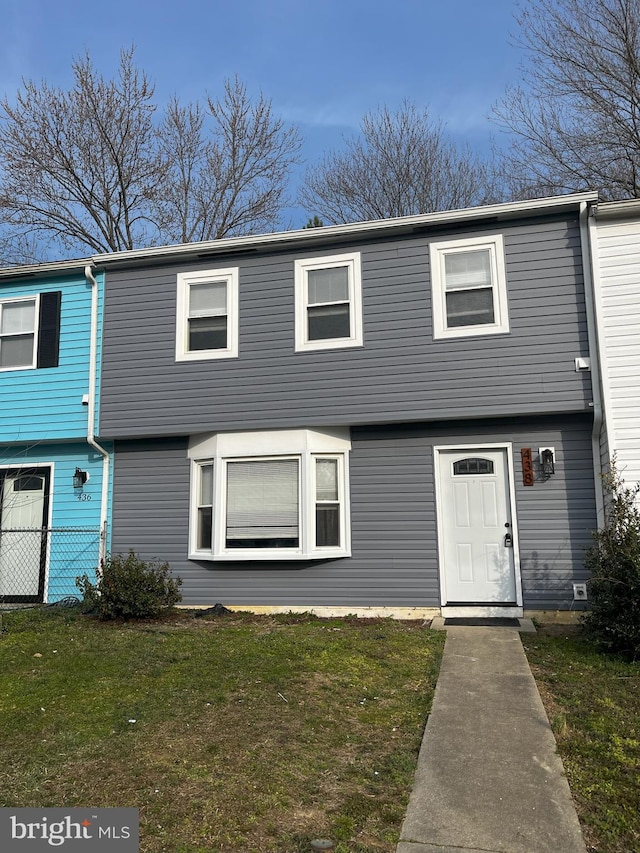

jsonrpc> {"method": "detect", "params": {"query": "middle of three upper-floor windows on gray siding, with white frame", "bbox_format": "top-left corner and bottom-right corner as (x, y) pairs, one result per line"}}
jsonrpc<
(295, 252), (363, 351)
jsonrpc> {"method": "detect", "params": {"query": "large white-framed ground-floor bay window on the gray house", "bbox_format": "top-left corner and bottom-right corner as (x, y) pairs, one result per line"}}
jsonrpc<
(189, 430), (350, 561)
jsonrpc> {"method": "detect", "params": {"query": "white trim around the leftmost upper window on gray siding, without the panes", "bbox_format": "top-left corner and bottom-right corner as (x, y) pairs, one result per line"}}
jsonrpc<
(176, 267), (240, 361)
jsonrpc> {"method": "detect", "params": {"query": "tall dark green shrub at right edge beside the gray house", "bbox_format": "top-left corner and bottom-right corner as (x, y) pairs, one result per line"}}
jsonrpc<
(582, 464), (640, 658)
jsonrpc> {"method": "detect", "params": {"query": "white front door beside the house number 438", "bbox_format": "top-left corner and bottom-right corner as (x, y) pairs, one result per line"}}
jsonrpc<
(438, 448), (517, 606)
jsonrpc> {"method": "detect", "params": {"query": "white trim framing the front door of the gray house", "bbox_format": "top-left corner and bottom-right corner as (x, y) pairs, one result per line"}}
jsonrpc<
(433, 442), (523, 617)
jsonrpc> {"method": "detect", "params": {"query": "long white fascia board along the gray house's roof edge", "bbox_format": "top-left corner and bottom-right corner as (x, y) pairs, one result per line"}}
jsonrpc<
(92, 192), (598, 267)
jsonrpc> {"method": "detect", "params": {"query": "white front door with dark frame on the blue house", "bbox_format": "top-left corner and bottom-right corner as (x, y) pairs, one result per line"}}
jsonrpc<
(0, 468), (49, 601)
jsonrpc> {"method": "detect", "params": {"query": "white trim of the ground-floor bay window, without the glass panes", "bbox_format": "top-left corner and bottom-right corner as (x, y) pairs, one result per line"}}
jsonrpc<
(189, 429), (351, 562)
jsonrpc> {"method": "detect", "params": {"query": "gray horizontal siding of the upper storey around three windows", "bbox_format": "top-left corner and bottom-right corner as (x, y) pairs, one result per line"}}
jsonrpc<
(100, 217), (591, 438)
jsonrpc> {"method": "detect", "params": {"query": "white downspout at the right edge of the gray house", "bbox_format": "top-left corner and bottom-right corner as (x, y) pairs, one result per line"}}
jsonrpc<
(580, 201), (605, 530)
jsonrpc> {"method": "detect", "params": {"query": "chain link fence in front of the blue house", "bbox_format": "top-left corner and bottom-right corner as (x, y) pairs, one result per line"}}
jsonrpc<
(0, 527), (102, 606)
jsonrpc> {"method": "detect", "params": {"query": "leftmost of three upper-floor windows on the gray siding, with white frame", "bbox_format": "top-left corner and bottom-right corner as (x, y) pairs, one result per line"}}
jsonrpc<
(176, 267), (239, 361)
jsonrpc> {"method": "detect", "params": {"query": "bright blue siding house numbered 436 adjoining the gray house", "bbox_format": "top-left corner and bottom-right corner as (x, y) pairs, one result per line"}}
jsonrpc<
(0, 261), (111, 603)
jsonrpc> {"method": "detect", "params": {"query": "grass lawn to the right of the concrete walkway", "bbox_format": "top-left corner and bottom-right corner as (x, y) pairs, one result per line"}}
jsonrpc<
(522, 627), (640, 853)
